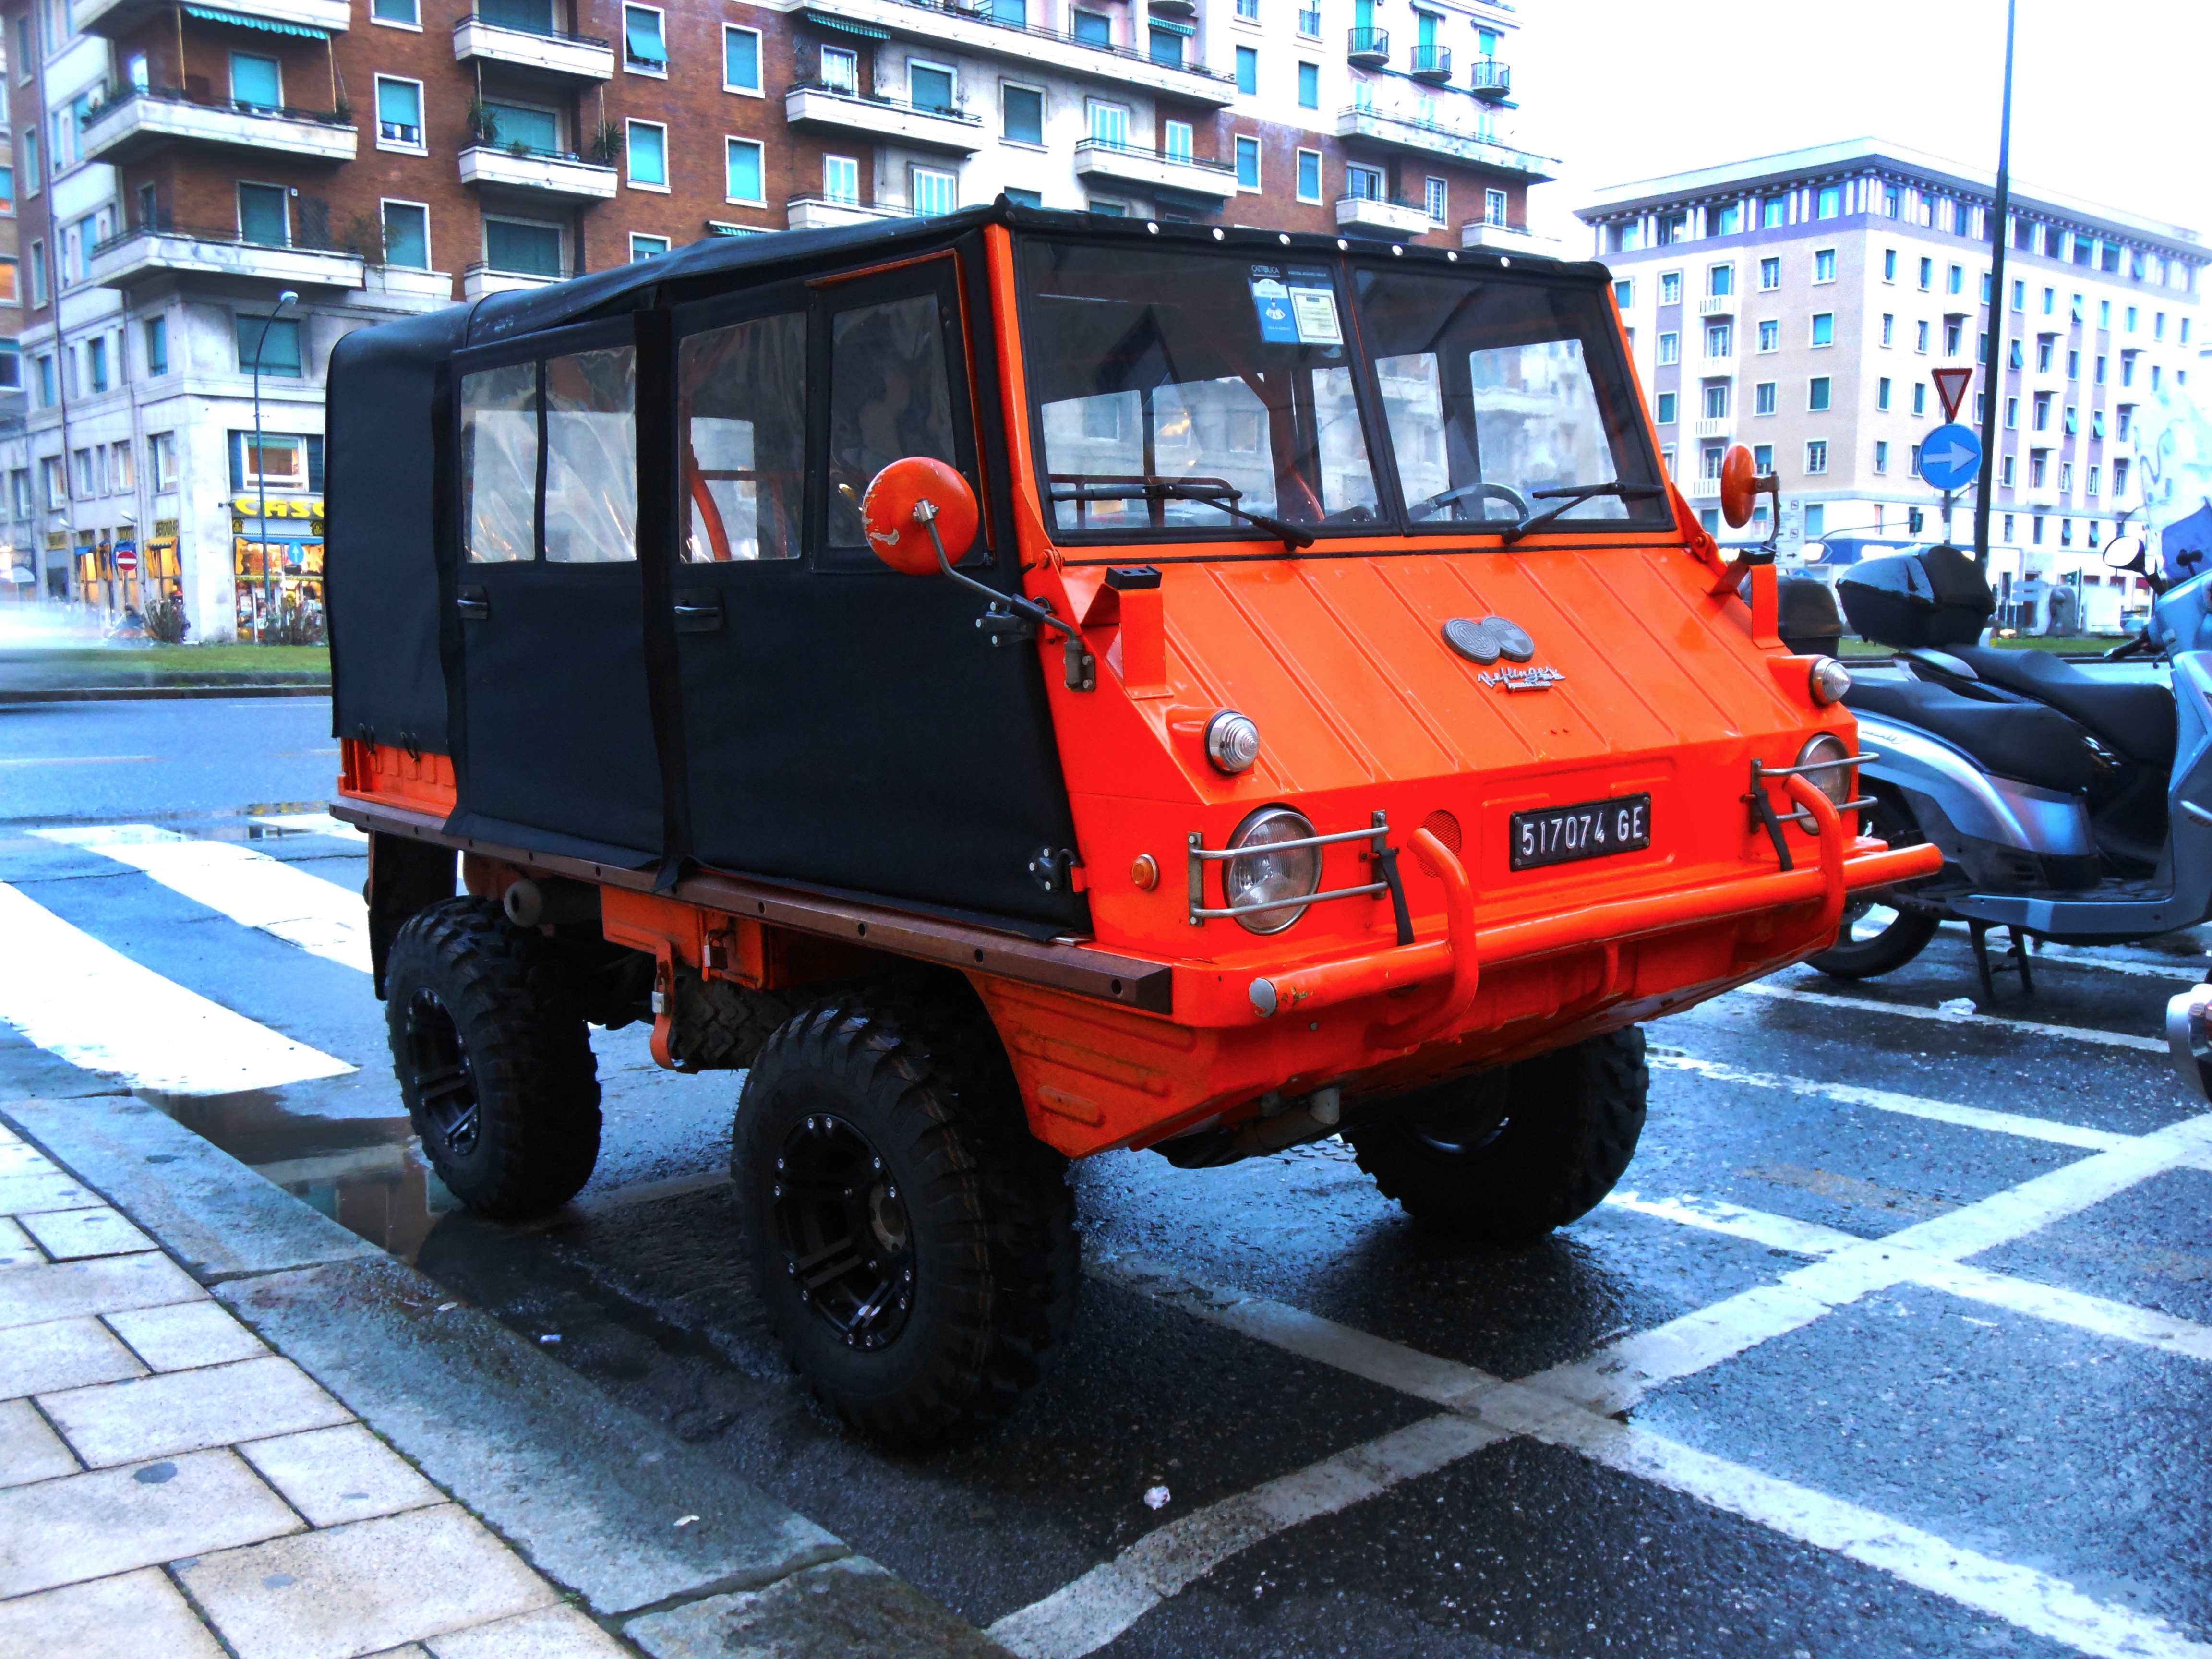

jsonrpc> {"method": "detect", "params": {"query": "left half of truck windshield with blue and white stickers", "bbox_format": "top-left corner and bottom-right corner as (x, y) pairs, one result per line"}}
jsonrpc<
(1024, 241), (1380, 540)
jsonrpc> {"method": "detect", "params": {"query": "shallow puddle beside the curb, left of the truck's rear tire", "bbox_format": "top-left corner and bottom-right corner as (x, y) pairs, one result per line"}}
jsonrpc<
(137, 1088), (460, 1263)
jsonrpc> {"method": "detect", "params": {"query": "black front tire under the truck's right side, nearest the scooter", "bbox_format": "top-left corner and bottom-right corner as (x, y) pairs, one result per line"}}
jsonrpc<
(1347, 1026), (1650, 1245)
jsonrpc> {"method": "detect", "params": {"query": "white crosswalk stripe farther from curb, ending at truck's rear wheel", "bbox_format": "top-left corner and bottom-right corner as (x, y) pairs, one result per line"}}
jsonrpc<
(31, 823), (370, 974)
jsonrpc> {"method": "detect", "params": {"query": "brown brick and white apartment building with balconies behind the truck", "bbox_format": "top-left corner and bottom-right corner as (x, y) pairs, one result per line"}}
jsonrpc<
(0, 0), (1549, 639)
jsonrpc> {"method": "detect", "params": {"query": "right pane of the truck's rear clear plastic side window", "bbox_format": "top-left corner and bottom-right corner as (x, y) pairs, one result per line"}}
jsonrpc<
(546, 345), (637, 564)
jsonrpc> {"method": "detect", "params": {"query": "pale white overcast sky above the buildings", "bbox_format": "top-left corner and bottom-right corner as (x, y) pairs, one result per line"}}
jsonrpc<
(1502, 0), (2212, 257)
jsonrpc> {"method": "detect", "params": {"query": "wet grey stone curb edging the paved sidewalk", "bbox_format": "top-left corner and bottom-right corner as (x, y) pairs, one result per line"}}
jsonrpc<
(0, 1095), (1007, 1659)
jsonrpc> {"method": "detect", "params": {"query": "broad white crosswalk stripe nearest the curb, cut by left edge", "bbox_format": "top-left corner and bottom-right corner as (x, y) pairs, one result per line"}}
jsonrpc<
(0, 883), (354, 1095)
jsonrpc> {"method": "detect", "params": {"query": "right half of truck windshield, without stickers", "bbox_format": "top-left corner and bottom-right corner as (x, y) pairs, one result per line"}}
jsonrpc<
(1356, 270), (1672, 531)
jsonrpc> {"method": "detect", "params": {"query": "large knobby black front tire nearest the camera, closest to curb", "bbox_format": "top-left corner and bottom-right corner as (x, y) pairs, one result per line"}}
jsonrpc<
(730, 989), (1080, 1447)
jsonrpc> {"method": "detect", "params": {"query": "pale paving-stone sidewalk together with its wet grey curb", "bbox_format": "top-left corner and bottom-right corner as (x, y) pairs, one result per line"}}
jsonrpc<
(0, 1099), (1000, 1659)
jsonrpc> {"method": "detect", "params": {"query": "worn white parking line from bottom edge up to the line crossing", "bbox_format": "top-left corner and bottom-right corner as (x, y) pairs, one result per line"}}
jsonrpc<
(989, 1416), (1506, 1659)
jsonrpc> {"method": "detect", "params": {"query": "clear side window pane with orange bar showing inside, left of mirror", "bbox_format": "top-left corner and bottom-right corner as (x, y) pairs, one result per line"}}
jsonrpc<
(677, 312), (807, 564)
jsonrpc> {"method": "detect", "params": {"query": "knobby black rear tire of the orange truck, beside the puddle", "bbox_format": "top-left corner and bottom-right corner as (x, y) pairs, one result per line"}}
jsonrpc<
(385, 898), (600, 1221)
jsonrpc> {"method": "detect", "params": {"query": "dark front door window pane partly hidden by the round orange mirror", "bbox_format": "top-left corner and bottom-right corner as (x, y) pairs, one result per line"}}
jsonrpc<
(830, 294), (960, 557)
